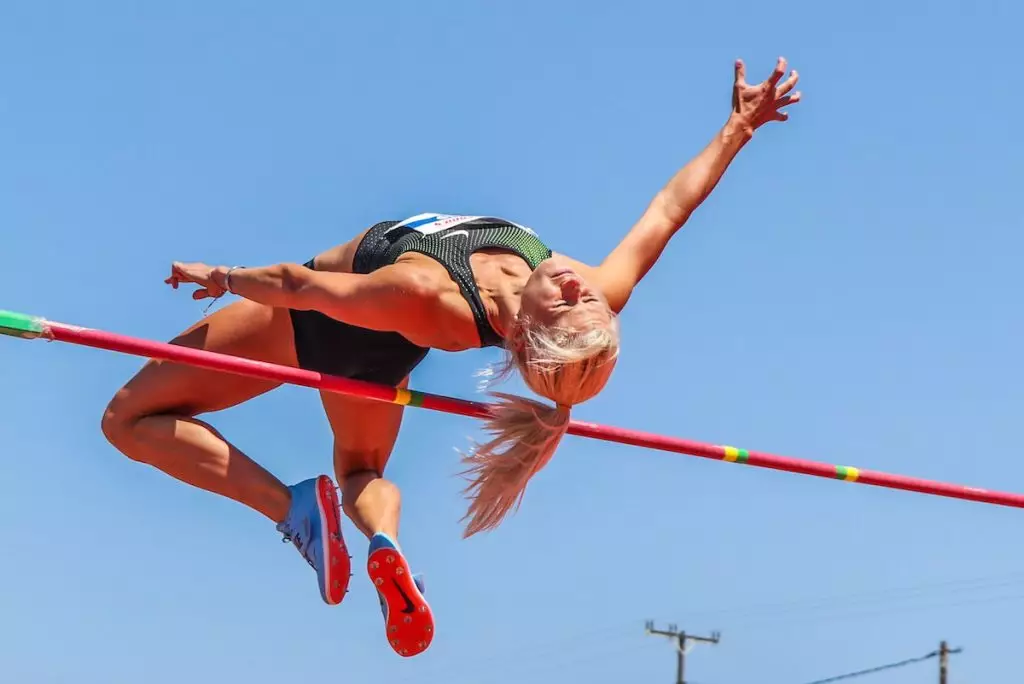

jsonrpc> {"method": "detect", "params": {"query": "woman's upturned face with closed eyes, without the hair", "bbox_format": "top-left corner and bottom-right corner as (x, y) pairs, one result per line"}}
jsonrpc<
(519, 256), (611, 331)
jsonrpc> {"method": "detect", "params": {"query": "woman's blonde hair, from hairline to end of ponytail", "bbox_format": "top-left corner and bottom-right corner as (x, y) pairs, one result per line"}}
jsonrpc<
(462, 316), (618, 538)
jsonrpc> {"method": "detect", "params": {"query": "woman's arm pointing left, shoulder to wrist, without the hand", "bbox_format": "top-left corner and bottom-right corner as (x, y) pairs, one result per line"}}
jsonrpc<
(213, 263), (437, 338)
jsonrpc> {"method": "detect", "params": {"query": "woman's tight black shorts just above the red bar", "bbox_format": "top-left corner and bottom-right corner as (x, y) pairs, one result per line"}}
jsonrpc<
(290, 241), (429, 385)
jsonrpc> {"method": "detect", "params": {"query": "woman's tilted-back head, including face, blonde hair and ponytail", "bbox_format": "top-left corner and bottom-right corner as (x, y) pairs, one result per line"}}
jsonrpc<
(465, 257), (618, 537)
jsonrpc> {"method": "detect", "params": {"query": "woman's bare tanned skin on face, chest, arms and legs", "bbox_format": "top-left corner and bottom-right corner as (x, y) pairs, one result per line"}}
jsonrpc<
(102, 57), (801, 610)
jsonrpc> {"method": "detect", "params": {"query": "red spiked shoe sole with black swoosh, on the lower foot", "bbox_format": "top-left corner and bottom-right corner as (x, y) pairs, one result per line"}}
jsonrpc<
(367, 548), (434, 657)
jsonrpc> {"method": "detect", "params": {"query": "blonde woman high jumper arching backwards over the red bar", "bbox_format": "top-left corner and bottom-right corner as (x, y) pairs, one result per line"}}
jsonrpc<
(102, 57), (800, 656)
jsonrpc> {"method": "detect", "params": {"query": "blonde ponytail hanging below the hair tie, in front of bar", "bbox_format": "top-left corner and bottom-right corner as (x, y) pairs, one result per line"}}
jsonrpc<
(462, 392), (569, 538)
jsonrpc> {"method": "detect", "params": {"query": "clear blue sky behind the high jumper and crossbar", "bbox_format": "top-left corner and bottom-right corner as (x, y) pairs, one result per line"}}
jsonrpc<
(0, 0), (1024, 684)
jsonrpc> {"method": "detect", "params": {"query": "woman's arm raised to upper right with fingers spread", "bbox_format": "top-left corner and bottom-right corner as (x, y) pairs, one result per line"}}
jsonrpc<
(592, 57), (800, 312)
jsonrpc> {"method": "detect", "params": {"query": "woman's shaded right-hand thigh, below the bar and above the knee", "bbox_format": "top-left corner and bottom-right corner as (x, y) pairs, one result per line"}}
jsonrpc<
(321, 377), (409, 479)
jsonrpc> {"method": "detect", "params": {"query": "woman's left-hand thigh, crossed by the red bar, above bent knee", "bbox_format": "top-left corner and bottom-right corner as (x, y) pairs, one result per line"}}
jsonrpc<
(111, 299), (297, 416)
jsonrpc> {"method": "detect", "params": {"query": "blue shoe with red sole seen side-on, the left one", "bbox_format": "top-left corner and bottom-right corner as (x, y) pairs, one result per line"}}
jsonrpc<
(278, 475), (352, 605)
